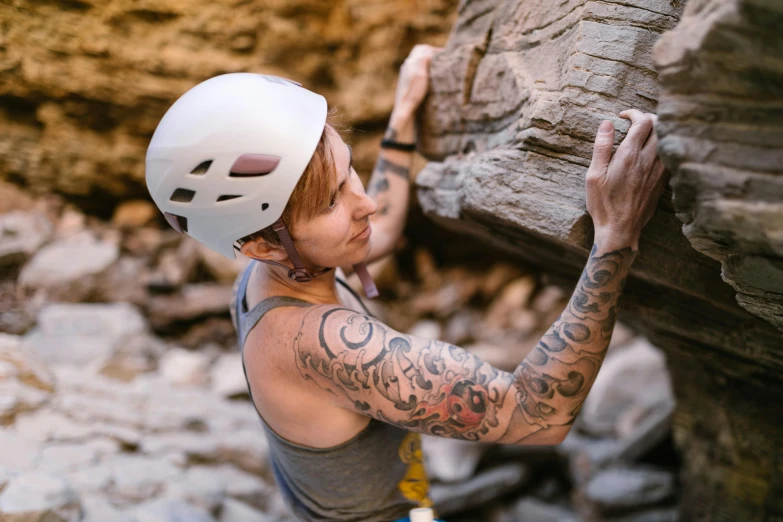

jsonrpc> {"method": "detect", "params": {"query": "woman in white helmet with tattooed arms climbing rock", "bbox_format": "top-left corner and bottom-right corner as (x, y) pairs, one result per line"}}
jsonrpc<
(146, 45), (666, 522)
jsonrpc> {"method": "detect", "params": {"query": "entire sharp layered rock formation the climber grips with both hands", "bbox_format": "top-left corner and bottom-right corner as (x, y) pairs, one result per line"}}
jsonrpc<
(417, 0), (783, 521)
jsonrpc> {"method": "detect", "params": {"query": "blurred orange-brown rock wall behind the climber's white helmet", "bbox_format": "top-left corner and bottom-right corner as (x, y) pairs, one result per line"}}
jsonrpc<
(0, 0), (457, 212)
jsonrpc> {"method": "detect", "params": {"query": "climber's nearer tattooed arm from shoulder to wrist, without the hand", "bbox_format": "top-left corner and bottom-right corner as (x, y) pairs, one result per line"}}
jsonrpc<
(293, 240), (636, 444)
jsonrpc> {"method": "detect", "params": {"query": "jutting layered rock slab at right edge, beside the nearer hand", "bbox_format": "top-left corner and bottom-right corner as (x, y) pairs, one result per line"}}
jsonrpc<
(654, 0), (783, 330)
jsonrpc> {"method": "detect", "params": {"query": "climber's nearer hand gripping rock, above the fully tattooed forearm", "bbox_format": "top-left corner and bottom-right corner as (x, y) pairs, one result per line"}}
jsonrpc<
(585, 109), (668, 249)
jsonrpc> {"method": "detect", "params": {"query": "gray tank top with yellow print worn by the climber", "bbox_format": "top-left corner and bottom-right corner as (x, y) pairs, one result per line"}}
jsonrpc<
(234, 262), (431, 522)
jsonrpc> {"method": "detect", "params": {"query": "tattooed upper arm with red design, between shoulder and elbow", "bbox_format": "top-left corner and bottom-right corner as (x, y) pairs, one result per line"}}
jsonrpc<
(294, 306), (513, 440)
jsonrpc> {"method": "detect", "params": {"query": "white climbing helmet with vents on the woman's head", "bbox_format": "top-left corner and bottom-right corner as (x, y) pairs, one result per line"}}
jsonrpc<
(146, 73), (327, 259)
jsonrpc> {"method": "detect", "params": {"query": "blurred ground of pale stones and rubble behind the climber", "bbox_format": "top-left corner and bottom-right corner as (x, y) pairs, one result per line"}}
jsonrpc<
(0, 185), (679, 522)
